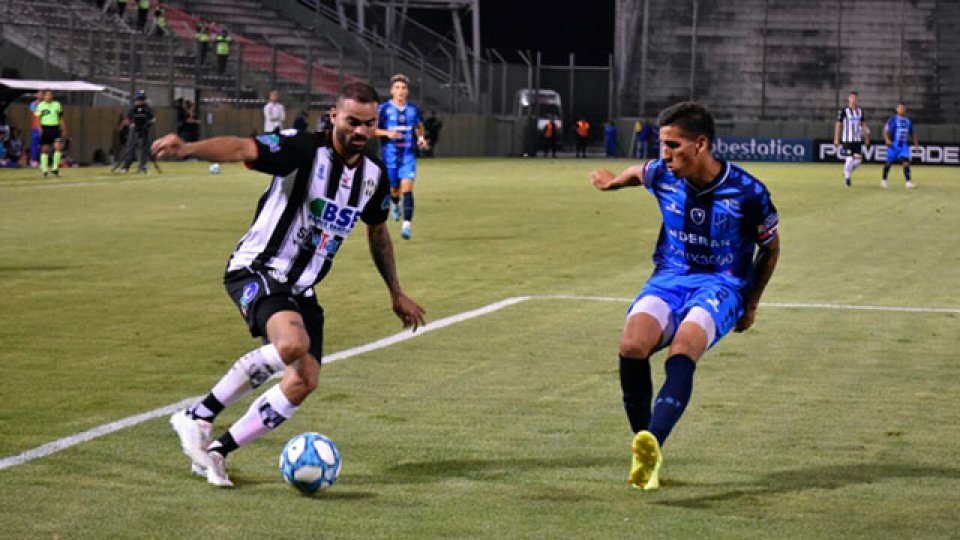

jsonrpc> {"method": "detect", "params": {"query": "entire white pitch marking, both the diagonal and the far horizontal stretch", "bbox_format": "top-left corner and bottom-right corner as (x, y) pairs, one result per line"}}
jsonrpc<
(0, 294), (960, 471)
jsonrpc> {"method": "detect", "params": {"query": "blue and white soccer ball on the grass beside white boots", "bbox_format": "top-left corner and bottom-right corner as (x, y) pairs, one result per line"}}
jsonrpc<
(280, 433), (341, 493)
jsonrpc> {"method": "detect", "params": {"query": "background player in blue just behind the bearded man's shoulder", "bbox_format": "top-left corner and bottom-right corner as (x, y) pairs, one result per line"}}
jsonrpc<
(377, 73), (428, 240)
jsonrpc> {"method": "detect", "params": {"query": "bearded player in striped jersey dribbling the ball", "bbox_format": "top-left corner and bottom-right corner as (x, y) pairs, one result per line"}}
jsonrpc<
(153, 83), (424, 486)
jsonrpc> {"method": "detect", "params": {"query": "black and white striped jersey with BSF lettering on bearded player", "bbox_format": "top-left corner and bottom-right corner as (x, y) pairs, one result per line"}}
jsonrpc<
(227, 130), (390, 294)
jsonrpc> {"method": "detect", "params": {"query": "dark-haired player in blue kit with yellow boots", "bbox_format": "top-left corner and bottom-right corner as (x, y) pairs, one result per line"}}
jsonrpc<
(591, 102), (780, 490)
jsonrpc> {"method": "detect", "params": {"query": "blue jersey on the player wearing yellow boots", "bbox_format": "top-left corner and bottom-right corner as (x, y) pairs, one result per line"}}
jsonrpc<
(641, 159), (779, 291)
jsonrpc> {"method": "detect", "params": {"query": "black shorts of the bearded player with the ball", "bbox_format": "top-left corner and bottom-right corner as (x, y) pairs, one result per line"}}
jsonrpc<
(223, 270), (323, 362)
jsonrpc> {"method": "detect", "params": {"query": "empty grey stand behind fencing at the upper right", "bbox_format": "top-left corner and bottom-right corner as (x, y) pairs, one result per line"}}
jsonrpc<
(623, 0), (960, 122)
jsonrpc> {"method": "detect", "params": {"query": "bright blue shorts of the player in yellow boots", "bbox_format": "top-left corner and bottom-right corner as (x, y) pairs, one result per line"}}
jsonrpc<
(627, 274), (743, 350)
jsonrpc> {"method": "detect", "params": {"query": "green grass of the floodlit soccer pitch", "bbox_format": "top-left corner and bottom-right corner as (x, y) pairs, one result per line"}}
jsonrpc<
(0, 159), (960, 539)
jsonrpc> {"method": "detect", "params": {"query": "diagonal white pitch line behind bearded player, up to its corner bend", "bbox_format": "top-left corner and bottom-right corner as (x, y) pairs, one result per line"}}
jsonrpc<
(0, 296), (530, 471)
